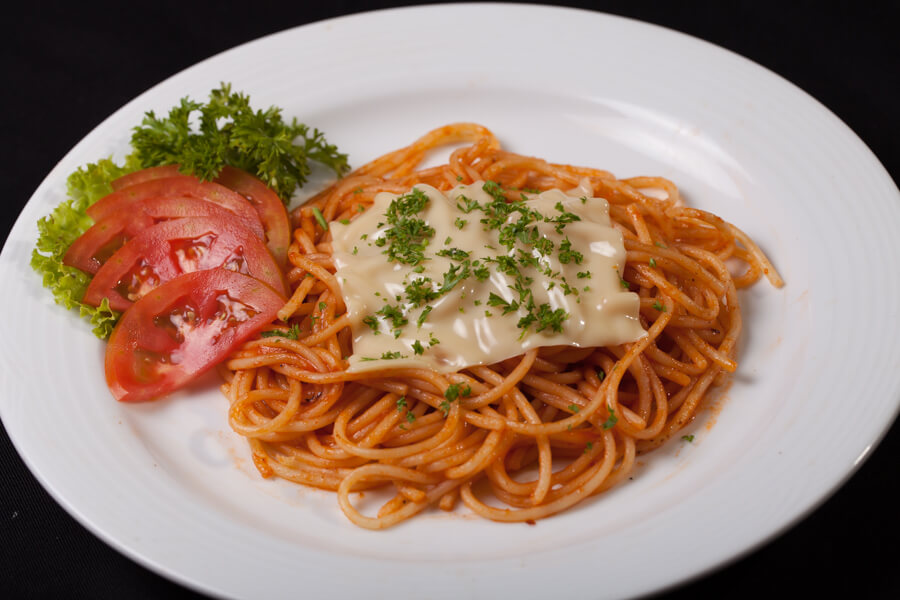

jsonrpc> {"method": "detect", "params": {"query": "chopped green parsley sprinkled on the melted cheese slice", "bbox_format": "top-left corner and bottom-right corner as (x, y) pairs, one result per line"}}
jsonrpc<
(363, 181), (630, 355)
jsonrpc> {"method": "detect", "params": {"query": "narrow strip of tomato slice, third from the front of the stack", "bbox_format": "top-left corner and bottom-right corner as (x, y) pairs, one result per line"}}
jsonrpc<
(63, 197), (259, 274)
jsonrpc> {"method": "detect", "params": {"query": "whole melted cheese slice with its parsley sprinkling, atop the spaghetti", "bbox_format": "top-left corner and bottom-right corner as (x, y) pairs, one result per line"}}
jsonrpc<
(332, 181), (646, 372)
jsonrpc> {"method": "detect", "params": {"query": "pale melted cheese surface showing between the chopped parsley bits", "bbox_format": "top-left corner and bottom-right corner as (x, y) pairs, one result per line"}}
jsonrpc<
(331, 182), (646, 372)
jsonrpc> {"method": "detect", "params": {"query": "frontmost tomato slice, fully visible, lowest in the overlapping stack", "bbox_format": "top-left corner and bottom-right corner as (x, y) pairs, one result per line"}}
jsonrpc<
(105, 268), (284, 402)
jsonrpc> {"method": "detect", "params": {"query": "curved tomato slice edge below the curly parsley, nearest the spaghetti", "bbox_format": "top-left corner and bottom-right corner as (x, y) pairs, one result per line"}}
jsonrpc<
(216, 166), (291, 267)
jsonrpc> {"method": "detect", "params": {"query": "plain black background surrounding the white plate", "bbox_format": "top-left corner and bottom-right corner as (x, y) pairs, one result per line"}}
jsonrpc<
(0, 0), (900, 599)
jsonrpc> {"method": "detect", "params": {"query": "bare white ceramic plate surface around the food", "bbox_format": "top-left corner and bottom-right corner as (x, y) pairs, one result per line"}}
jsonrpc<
(0, 5), (900, 598)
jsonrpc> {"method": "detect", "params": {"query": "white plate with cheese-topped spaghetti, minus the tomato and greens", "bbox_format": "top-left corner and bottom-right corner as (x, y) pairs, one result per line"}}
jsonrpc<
(0, 5), (900, 598)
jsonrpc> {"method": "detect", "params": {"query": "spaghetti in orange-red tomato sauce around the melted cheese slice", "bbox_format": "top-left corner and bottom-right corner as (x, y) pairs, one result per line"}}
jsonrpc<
(222, 123), (783, 529)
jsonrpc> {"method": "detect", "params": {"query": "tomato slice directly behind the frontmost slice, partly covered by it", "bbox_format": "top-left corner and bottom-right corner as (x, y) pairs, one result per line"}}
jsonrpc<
(82, 216), (287, 310)
